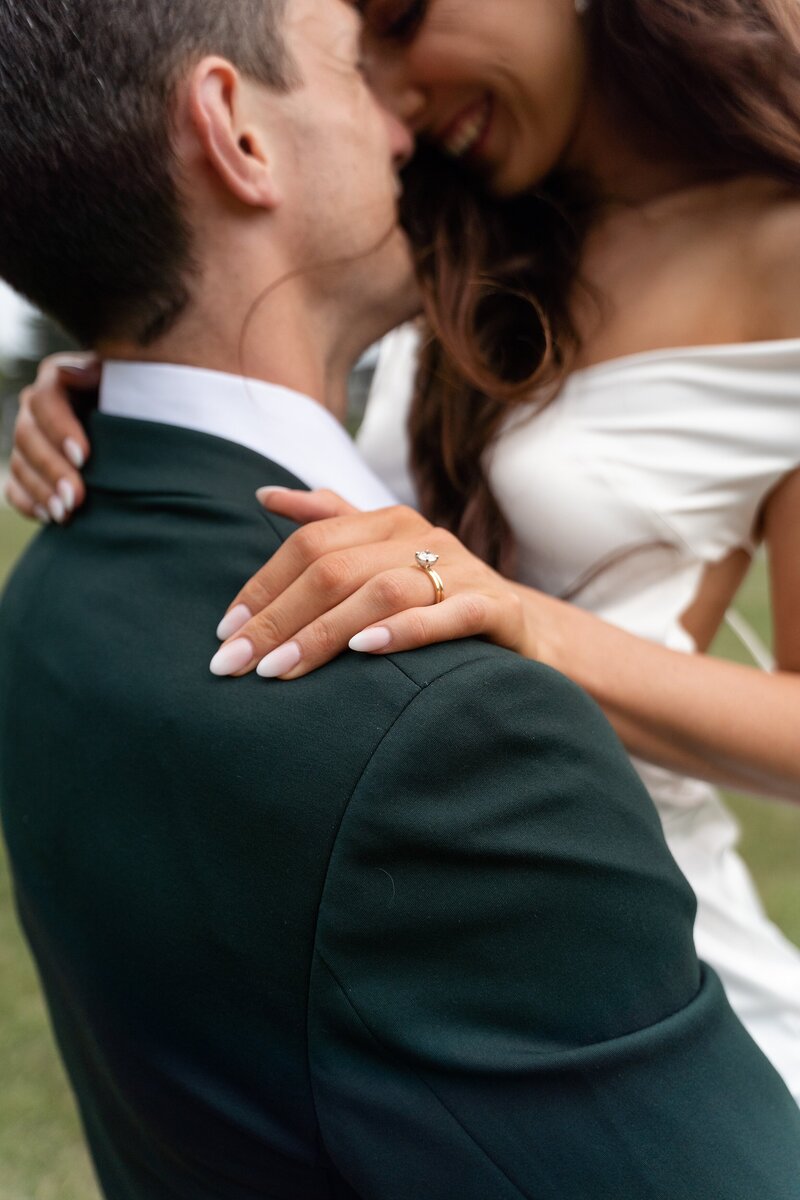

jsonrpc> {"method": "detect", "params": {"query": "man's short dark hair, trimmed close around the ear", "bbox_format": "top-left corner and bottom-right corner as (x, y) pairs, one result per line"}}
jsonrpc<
(0, 0), (296, 346)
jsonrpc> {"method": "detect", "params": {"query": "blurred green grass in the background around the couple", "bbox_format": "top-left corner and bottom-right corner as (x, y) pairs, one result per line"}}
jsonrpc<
(0, 508), (800, 1200)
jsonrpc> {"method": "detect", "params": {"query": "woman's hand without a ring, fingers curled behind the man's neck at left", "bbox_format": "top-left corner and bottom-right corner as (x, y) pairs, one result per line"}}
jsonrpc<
(6, 354), (101, 524)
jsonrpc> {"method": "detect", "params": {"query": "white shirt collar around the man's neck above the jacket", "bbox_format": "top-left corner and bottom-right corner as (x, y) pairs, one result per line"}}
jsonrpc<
(100, 362), (397, 509)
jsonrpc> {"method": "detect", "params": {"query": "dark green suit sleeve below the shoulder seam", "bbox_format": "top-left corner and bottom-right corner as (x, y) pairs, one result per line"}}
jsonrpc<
(309, 655), (800, 1200)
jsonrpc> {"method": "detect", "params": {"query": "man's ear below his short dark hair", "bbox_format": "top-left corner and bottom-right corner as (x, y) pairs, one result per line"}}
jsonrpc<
(188, 58), (279, 209)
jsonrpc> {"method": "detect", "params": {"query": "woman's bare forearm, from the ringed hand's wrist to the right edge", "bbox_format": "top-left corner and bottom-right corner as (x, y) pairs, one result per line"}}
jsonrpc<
(519, 588), (800, 803)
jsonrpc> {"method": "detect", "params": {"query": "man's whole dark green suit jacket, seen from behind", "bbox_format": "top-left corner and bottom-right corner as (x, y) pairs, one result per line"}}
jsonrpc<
(0, 416), (800, 1200)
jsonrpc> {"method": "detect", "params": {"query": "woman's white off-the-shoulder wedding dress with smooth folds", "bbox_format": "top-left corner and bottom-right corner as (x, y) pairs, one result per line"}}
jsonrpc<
(360, 328), (800, 1102)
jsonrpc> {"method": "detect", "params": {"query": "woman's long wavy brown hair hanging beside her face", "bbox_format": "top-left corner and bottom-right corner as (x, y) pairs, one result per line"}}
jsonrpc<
(404, 0), (800, 575)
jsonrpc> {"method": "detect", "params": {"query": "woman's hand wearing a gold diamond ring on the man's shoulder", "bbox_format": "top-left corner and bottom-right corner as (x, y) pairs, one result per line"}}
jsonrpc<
(211, 488), (529, 680)
